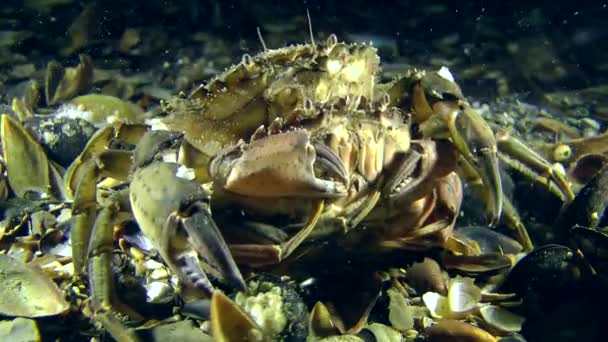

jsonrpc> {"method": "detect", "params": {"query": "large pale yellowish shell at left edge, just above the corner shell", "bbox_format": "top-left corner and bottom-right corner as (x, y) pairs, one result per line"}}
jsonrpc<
(0, 255), (70, 318)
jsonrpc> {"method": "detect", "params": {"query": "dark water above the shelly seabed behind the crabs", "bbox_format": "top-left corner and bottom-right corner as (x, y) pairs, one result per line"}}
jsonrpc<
(0, 0), (608, 96)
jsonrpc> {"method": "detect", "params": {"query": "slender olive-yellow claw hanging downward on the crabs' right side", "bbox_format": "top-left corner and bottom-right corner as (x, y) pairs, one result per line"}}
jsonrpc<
(443, 103), (503, 225)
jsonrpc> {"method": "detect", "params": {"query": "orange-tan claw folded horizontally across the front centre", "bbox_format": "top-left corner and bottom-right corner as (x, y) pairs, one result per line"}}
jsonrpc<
(209, 131), (348, 198)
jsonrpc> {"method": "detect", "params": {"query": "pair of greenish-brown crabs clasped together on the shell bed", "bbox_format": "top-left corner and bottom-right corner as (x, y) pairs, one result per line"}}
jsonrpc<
(65, 35), (573, 340)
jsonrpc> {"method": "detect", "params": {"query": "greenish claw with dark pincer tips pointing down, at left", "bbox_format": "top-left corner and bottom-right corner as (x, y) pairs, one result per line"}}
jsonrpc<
(129, 162), (246, 295)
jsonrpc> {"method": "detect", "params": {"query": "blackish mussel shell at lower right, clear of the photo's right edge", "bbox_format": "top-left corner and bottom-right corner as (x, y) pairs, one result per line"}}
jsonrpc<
(498, 245), (581, 296)
